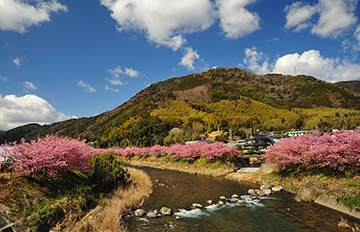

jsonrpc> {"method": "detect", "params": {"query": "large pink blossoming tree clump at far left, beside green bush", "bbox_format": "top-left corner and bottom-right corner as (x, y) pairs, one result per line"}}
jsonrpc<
(0, 135), (98, 177)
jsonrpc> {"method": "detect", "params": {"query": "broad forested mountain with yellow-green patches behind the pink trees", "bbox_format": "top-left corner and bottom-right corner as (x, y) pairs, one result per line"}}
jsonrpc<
(0, 68), (360, 147)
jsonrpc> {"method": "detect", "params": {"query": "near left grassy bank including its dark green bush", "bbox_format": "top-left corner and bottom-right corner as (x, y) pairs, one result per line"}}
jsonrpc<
(0, 157), (152, 231)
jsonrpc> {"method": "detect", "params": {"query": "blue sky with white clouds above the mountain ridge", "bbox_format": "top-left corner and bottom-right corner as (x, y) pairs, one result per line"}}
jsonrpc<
(0, 0), (360, 130)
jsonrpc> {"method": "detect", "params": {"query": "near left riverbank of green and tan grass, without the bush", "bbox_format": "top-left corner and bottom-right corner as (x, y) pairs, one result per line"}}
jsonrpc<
(0, 168), (152, 231)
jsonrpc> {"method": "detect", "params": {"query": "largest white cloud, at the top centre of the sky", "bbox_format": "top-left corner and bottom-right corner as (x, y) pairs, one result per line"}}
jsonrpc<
(101, 0), (216, 51)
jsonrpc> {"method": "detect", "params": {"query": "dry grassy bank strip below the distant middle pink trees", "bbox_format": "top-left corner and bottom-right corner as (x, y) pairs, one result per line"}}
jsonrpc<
(119, 155), (238, 176)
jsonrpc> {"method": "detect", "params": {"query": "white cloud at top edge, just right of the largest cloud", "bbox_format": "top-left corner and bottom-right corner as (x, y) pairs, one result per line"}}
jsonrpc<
(216, 0), (260, 39)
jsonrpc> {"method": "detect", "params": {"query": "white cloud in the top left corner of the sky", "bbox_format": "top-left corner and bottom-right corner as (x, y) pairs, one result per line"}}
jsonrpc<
(0, 0), (67, 33)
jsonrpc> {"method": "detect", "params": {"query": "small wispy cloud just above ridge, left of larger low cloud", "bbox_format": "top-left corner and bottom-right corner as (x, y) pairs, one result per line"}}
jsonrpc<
(239, 47), (270, 74)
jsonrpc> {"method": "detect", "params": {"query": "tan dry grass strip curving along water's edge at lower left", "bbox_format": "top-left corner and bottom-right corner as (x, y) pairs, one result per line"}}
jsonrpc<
(52, 168), (152, 232)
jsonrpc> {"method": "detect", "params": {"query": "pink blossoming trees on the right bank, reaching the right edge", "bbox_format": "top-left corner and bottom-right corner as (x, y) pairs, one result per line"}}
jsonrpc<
(264, 128), (360, 172)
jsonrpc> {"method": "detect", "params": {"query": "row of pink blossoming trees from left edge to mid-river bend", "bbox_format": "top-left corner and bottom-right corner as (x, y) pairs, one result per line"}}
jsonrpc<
(0, 135), (241, 177)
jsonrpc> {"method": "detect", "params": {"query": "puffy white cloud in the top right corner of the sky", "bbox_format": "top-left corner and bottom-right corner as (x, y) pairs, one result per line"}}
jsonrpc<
(284, 0), (358, 38)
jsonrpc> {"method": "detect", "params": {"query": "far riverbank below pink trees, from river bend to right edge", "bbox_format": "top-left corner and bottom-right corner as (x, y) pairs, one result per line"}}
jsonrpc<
(120, 156), (360, 222)
